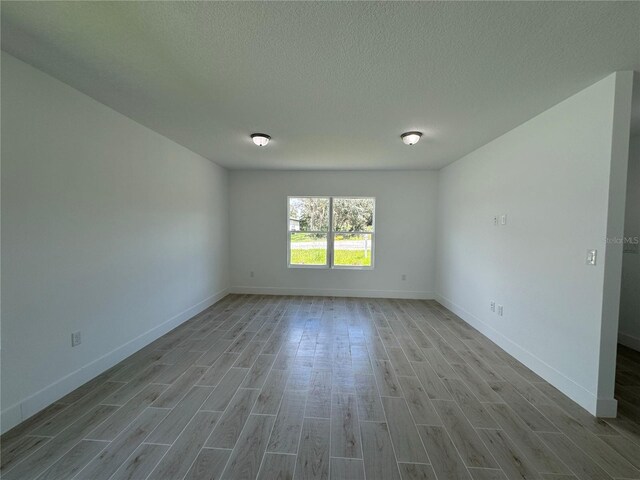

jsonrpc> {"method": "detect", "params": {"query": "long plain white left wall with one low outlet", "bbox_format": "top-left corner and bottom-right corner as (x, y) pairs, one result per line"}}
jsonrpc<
(2, 53), (228, 431)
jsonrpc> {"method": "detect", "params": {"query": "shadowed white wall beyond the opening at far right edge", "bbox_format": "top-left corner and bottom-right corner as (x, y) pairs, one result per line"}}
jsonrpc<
(619, 134), (640, 351)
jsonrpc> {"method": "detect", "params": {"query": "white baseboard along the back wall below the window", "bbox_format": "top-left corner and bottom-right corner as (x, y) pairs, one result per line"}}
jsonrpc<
(229, 285), (434, 300)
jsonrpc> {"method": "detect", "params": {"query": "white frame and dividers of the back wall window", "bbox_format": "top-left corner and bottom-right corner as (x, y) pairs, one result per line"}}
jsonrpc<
(286, 195), (376, 270)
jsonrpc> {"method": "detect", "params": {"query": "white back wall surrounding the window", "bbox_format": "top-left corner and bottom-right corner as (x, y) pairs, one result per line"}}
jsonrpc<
(229, 171), (437, 298)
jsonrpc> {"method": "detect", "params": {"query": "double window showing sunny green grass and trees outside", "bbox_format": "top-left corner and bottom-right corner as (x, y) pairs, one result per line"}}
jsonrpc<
(287, 197), (375, 269)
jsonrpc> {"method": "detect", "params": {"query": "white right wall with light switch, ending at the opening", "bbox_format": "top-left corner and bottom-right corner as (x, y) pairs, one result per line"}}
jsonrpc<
(437, 72), (631, 415)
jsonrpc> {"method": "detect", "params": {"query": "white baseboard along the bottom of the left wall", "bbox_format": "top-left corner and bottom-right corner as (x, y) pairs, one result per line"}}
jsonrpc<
(0, 289), (228, 433)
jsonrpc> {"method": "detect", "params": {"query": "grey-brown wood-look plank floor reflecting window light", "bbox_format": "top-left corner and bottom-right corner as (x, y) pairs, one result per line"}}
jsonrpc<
(2, 295), (640, 480)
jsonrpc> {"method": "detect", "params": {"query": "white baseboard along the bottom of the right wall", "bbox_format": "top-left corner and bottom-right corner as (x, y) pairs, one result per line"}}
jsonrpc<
(435, 294), (617, 417)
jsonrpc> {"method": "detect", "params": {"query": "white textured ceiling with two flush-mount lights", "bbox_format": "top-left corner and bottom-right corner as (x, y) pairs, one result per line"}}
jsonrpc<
(2, 1), (640, 169)
